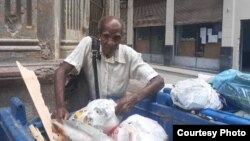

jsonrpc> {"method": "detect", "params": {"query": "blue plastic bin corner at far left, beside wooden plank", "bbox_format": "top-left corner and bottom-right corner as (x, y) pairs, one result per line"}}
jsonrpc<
(0, 97), (35, 141)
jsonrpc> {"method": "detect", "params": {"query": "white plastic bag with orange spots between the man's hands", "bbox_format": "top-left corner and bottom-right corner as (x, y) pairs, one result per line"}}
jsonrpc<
(70, 99), (119, 133)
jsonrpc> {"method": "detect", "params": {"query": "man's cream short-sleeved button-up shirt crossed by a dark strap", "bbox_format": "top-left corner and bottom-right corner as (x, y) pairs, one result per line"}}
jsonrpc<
(64, 36), (158, 98)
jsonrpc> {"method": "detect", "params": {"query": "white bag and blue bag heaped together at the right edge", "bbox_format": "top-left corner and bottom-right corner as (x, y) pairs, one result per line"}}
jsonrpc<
(170, 69), (250, 119)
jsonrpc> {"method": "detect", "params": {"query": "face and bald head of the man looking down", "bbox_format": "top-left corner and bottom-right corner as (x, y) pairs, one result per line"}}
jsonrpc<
(100, 19), (122, 58)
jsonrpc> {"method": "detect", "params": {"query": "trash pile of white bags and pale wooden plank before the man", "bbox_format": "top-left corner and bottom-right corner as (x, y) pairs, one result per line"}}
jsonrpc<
(17, 62), (167, 141)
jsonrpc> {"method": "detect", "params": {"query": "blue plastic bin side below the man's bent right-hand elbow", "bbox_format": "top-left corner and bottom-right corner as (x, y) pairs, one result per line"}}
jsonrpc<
(125, 93), (225, 141)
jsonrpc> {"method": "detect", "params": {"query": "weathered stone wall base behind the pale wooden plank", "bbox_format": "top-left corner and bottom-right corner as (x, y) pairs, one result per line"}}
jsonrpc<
(0, 65), (57, 120)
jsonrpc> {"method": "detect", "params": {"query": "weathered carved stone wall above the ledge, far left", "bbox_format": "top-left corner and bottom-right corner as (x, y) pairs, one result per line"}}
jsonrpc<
(0, 0), (54, 66)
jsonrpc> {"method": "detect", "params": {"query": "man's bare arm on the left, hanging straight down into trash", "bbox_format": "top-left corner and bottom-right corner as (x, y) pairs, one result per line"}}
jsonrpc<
(54, 62), (74, 119)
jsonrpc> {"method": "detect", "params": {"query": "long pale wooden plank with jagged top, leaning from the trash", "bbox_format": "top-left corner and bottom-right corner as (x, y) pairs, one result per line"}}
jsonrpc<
(16, 61), (54, 141)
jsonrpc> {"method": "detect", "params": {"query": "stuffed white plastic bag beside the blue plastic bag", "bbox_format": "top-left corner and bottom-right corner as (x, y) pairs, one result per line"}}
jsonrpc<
(171, 78), (222, 110)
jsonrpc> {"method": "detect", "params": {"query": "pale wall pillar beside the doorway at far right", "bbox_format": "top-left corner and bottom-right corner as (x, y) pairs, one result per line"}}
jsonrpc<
(222, 0), (250, 69)
